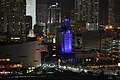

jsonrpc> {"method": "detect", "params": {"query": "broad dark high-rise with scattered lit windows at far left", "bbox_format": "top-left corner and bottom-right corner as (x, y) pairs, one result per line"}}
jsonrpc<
(0, 0), (26, 42)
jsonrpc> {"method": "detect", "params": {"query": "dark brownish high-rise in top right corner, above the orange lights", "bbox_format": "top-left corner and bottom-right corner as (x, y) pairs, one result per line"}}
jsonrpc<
(108, 0), (120, 29)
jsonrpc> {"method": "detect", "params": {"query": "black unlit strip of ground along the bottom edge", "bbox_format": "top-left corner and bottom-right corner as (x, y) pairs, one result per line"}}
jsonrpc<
(0, 71), (120, 80)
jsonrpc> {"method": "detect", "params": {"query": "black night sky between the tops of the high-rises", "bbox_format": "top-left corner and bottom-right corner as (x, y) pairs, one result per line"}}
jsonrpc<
(37, 0), (74, 10)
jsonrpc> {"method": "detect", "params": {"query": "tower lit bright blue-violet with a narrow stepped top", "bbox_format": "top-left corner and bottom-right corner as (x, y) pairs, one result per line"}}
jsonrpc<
(61, 19), (72, 54)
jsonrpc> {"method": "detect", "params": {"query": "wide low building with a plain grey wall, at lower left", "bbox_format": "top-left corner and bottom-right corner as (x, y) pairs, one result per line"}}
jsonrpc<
(0, 41), (41, 68)
